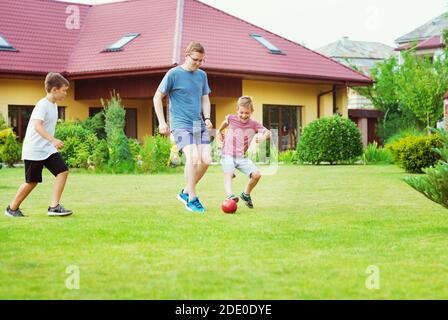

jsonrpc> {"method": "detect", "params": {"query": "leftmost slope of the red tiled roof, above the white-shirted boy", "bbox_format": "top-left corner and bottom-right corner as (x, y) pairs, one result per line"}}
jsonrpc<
(0, 0), (90, 74)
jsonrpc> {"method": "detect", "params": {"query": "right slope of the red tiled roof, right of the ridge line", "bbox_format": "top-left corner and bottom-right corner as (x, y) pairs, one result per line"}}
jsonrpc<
(181, 0), (371, 82)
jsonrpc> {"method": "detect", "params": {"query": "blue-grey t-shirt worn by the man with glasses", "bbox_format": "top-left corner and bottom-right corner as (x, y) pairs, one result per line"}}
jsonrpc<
(158, 66), (211, 130)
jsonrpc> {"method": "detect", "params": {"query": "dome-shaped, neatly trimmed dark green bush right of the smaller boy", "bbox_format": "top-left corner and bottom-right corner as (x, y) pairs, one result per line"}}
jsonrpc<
(297, 116), (363, 164)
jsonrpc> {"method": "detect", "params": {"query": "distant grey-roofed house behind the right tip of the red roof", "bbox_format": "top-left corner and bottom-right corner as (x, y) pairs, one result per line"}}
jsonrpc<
(317, 37), (394, 146)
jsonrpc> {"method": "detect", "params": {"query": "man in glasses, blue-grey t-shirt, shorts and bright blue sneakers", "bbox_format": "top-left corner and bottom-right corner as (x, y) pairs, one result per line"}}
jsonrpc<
(153, 42), (213, 213)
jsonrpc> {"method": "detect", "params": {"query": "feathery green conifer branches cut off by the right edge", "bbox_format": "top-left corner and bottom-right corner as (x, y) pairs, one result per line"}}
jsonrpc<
(404, 130), (448, 208)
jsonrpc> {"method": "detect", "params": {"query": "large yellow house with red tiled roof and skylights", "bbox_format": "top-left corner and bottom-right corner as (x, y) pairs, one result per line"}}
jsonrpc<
(0, 0), (372, 150)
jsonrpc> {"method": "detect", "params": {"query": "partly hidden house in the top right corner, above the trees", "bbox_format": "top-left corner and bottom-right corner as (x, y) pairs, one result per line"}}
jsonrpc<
(395, 14), (448, 63)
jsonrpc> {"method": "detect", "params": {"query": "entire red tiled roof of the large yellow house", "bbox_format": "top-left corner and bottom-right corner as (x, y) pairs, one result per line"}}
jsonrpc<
(0, 0), (371, 83)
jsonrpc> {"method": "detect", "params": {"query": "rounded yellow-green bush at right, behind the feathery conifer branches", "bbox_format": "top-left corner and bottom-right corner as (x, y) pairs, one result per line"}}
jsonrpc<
(386, 134), (442, 173)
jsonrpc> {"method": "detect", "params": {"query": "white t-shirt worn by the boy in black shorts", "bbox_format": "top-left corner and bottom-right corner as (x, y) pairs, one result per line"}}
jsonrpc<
(22, 98), (58, 160)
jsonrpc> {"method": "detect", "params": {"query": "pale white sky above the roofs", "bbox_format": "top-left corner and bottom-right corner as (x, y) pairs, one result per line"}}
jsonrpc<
(64, 0), (448, 49)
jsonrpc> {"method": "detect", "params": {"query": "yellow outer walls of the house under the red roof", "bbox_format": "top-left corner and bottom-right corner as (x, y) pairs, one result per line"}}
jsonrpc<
(0, 78), (348, 140)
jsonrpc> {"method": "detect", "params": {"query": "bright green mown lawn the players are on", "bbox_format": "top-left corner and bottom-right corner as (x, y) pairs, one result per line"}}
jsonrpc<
(0, 166), (448, 299)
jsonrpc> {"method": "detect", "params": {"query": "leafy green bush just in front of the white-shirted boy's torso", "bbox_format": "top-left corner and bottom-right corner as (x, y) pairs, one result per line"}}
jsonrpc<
(55, 122), (98, 168)
